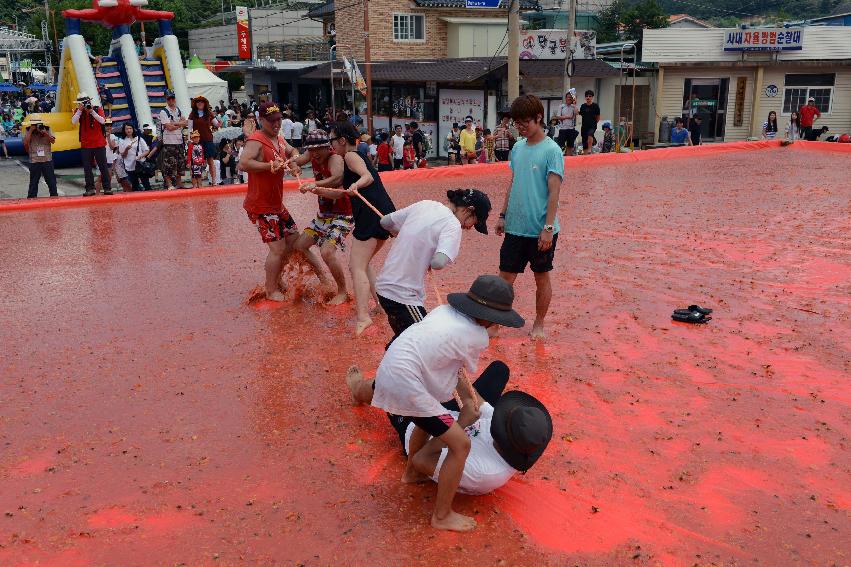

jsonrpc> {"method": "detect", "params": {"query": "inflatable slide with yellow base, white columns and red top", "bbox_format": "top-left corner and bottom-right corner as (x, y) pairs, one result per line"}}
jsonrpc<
(22, 0), (190, 167)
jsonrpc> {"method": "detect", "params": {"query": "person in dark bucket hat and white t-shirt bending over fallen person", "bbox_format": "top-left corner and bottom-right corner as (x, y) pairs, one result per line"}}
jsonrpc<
(346, 276), (525, 532)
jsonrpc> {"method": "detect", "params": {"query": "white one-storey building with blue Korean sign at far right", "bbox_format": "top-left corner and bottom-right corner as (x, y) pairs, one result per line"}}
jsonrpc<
(642, 26), (851, 141)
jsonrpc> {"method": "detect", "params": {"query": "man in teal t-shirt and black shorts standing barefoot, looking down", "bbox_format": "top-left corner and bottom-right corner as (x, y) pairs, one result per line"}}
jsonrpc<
(496, 95), (564, 339)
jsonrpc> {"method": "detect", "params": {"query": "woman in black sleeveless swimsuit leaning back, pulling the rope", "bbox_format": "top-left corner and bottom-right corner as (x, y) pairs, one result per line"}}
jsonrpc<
(331, 122), (396, 335)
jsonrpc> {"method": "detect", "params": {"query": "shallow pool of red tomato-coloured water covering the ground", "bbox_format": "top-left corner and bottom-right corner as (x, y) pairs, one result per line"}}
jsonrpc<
(0, 148), (851, 566)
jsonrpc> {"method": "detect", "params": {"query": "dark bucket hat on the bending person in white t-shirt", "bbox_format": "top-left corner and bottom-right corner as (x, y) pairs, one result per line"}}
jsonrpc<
(446, 276), (526, 328)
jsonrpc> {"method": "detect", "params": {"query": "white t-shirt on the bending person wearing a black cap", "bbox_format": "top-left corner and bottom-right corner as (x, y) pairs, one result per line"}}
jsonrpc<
(375, 201), (461, 306)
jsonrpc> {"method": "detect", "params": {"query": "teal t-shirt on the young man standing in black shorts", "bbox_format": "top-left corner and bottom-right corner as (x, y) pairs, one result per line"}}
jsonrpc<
(505, 137), (564, 238)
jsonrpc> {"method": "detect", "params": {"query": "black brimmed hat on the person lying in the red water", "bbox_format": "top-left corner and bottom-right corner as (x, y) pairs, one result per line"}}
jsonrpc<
(491, 391), (553, 472)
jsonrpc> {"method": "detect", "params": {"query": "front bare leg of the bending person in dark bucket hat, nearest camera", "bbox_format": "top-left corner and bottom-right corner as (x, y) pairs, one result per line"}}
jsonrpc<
(430, 423), (476, 532)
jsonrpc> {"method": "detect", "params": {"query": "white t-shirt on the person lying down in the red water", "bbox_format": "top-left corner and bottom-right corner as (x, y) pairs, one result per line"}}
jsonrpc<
(405, 402), (517, 495)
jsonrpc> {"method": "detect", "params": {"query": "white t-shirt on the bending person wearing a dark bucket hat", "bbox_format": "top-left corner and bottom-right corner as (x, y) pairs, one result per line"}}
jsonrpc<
(372, 305), (489, 417)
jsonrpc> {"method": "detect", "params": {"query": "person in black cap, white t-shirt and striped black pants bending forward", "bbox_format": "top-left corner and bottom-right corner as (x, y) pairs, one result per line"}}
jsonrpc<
(375, 189), (491, 343)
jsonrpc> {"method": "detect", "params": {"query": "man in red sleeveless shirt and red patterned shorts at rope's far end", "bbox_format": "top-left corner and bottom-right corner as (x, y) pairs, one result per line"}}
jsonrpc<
(239, 101), (326, 301)
